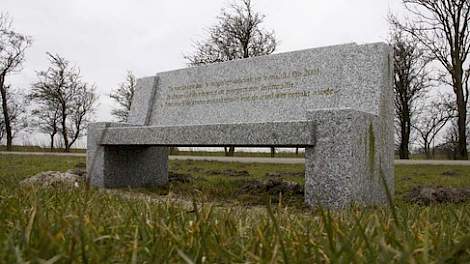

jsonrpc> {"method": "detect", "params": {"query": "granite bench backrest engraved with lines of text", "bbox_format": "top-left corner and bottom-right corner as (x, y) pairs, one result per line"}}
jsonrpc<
(128, 43), (393, 126)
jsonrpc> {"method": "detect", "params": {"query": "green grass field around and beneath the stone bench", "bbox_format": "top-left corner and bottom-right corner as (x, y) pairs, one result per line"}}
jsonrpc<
(0, 155), (470, 263)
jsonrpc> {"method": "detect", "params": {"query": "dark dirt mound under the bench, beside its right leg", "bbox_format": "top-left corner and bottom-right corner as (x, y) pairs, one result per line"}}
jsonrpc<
(240, 179), (304, 194)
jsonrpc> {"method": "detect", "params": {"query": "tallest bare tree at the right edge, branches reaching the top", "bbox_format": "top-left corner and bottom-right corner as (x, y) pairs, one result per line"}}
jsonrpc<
(394, 0), (470, 159)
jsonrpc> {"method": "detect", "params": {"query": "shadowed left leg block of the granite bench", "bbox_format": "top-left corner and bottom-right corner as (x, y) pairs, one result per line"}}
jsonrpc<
(87, 123), (168, 188)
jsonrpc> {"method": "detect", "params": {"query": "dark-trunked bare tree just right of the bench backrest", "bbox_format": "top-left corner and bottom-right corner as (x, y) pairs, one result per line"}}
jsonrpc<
(390, 28), (430, 159)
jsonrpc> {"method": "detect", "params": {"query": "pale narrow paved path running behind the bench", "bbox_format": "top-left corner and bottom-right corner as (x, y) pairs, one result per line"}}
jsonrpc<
(0, 151), (470, 166)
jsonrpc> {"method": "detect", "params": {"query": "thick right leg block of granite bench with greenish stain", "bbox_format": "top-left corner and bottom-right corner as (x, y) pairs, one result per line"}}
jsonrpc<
(305, 109), (393, 209)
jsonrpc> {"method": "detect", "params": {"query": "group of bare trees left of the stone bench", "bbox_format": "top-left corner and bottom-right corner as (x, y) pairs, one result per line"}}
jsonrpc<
(0, 13), (97, 152)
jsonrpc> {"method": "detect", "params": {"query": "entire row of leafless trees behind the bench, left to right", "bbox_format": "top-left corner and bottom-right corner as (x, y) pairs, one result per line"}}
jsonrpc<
(0, 0), (470, 159)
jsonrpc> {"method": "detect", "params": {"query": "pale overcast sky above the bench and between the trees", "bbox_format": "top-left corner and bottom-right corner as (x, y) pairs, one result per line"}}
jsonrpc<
(0, 0), (401, 146)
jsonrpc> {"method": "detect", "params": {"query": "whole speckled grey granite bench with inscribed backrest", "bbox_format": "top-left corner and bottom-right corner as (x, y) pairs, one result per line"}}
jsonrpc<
(87, 43), (394, 208)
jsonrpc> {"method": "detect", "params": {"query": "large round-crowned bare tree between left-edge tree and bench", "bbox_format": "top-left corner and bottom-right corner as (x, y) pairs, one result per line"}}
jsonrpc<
(30, 53), (97, 152)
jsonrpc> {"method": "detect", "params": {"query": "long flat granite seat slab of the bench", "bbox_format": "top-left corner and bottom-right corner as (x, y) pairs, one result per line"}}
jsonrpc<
(98, 121), (315, 147)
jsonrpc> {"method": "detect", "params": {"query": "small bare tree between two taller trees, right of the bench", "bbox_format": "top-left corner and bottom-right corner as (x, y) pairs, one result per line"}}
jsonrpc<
(413, 96), (455, 159)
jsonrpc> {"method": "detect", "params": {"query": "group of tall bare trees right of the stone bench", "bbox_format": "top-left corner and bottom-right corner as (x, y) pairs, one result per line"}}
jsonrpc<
(390, 0), (470, 159)
